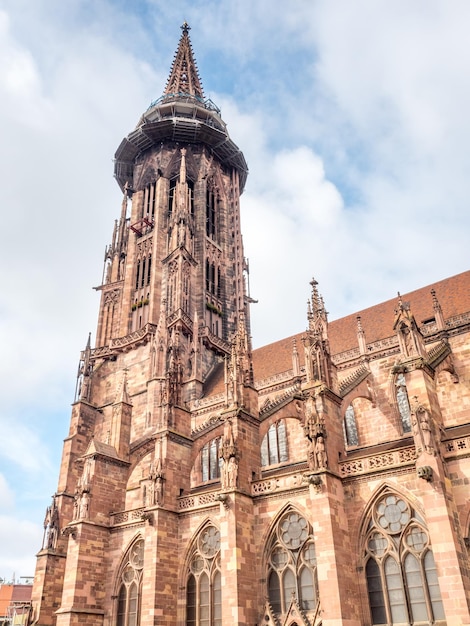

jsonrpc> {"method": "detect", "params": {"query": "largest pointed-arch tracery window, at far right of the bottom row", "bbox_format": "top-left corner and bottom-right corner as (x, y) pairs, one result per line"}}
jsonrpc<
(364, 492), (445, 626)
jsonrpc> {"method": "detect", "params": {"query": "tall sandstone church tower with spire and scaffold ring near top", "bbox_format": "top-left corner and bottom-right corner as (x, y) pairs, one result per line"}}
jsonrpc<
(31, 23), (252, 626)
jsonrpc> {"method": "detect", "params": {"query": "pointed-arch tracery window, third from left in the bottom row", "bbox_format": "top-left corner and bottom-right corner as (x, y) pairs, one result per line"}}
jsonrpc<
(267, 510), (318, 615)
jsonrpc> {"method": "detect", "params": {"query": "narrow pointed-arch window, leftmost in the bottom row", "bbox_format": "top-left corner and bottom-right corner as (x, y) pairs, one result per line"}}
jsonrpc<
(116, 539), (144, 626)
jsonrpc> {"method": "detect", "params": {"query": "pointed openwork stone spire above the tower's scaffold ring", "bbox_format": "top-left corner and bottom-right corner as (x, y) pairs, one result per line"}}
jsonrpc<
(163, 22), (204, 100)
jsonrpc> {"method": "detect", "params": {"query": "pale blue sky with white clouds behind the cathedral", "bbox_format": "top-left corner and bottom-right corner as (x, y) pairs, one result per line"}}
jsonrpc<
(0, 0), (470, 581)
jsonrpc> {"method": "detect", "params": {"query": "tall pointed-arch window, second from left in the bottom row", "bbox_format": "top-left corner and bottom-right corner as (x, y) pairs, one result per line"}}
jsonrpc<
(186, 525), (222, 626)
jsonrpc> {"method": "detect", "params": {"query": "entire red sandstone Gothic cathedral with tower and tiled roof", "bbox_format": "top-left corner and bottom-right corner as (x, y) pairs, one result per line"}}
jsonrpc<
(29, 24), (470, 626)
